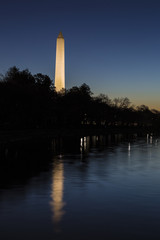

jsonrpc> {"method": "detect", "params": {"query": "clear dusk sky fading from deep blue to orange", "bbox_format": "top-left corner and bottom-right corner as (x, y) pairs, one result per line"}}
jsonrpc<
(0, 0), (160, 109)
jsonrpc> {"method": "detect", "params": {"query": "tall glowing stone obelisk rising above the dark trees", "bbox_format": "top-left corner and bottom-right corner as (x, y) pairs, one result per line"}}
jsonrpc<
(55, 32), (65, 91)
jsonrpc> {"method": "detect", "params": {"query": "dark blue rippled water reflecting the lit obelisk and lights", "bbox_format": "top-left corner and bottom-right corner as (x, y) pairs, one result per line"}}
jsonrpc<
(0, 134), (160, 240)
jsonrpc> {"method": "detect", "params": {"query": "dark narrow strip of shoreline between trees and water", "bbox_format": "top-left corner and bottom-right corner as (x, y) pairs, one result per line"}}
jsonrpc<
(0, 127), (156, 143)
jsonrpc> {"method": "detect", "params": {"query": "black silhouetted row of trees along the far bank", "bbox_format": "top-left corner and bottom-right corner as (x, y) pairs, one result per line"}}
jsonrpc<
(0, 67), (160, 130)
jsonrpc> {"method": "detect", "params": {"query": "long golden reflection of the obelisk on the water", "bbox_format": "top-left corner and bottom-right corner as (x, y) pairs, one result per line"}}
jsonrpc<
(51, 161), (64, 228)
